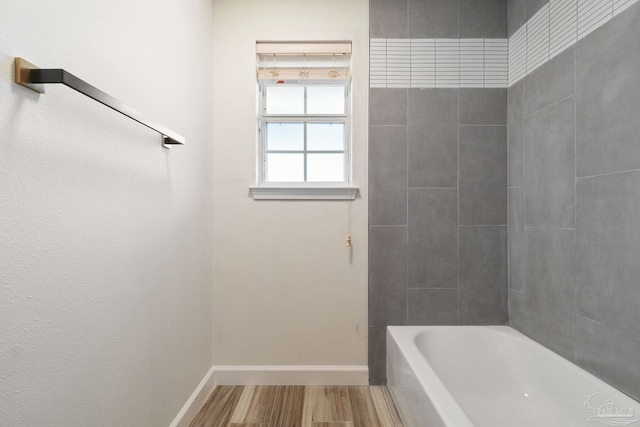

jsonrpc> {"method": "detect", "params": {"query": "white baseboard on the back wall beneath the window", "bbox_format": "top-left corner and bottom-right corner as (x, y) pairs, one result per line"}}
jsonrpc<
(213, 365), (369, 385)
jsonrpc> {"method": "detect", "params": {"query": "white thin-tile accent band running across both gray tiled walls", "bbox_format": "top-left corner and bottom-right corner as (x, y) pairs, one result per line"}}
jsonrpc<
(369, 0), (638, 88)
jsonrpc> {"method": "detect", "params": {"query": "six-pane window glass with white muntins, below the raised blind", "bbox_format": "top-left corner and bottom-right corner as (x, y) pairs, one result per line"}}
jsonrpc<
(260, 83), (349, 183)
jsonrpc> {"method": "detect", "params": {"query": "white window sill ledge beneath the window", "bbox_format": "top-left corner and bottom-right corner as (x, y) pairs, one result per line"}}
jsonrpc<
(249, 185), (359, 200)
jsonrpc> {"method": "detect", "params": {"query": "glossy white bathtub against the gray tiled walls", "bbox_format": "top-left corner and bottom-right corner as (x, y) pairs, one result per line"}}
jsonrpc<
(387, 326), (640, 427)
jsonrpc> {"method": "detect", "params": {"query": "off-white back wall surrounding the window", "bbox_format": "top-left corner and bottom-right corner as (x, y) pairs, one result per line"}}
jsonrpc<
(213, 0), (369, 379)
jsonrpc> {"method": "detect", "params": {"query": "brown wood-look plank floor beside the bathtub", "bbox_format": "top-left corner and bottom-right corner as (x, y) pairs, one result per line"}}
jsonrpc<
(190, 386), (402, 427)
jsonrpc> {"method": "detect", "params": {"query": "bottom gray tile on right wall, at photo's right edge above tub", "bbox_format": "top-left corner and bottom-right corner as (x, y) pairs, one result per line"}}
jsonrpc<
(576, 316), (640, 400)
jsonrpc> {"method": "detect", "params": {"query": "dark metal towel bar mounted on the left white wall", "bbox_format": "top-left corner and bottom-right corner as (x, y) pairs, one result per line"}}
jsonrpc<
(15, 58), (185, 148)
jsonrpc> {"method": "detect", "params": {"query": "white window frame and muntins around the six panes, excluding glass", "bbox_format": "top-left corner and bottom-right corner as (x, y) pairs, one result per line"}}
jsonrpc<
(257, 80), (351, 188)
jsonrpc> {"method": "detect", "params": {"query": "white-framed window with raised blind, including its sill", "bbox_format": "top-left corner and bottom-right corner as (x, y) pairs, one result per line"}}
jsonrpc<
(252, 43), (355, 198)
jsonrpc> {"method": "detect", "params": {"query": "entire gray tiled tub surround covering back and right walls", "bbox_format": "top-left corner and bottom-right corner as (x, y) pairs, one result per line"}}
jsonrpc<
(369, 0), (640, 399)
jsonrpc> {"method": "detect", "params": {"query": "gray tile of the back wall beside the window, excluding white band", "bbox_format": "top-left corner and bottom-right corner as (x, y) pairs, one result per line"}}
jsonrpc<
(369, 0), (508, 384)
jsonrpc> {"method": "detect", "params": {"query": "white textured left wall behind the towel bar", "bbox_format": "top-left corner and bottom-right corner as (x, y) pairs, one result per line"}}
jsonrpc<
(0, 0), (213, 427)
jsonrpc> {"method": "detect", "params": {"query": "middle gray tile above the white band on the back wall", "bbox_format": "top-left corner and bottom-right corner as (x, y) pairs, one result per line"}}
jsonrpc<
(408, 0), (458, 38)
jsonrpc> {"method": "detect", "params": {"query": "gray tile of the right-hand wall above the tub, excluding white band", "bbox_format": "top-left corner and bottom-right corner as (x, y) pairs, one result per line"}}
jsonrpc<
(507, 0), (640, 399)
